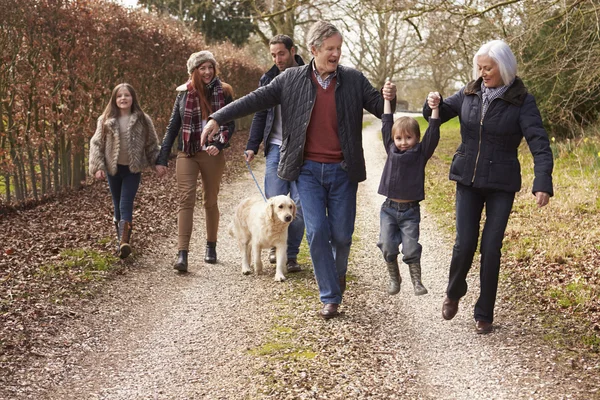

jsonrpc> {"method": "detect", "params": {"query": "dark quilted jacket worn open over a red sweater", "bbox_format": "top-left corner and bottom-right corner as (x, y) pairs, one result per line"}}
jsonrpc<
(210, 62), (395, 182)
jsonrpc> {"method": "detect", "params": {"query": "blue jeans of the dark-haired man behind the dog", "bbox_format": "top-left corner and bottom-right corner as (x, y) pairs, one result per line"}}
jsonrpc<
(265, 144), (304, 259)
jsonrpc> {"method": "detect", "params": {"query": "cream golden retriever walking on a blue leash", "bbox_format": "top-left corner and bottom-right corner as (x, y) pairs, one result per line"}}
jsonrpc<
(229, 195), (296, 282)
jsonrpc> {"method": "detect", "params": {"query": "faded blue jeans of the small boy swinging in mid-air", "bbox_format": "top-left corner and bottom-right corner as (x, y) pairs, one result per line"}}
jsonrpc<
(377, 199), (423, 264)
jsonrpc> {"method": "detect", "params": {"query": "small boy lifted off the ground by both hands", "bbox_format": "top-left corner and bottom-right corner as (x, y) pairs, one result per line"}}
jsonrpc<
(377, 89), (440, 296)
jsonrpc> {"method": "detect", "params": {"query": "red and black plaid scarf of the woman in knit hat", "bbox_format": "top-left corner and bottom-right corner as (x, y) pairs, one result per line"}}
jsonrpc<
(183, 77), (229, 156)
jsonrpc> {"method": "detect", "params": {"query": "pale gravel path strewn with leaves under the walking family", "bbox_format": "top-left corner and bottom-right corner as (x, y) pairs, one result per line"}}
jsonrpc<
(15, 114), (598, 400)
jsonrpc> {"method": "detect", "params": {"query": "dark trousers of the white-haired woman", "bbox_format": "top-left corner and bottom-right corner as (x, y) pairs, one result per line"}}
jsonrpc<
(446, 183), (515, 322)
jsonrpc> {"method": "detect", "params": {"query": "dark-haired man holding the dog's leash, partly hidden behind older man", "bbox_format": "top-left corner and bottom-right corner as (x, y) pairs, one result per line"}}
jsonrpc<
(245, 35), (304, 272)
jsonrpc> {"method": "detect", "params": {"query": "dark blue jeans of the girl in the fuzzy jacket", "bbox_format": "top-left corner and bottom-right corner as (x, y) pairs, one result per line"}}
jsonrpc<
(106, 164), (142, 222)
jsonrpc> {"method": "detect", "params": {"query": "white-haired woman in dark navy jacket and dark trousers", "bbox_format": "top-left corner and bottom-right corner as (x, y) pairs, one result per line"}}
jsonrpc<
(423, 40), (553, 334)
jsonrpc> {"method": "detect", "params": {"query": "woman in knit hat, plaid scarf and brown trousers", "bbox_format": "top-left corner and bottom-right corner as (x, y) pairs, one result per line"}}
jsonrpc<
(156, 50), (235, 272)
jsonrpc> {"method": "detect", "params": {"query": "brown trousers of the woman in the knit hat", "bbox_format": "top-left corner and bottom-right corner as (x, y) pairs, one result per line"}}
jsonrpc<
(175, 151), (225, 250)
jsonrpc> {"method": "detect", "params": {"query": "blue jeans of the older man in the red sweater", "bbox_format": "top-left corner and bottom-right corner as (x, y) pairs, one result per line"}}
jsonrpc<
(297, 161), (358, 304)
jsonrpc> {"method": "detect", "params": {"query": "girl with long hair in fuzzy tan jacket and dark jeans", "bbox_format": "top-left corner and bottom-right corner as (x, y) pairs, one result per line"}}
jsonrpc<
(89, 83), (159, 258)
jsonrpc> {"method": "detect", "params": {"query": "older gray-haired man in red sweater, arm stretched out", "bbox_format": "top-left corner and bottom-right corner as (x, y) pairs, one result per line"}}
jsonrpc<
(202, 21), (396, 319)
